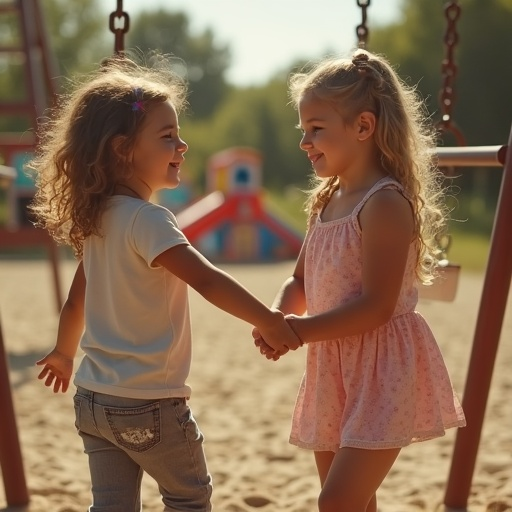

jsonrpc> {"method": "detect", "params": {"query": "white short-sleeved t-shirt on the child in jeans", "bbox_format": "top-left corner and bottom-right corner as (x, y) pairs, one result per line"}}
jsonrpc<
(74, 196), (191, 399)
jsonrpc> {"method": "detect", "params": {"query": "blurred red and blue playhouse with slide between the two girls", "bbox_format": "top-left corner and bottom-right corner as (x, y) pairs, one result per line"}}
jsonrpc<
(176, 148), (303, 263)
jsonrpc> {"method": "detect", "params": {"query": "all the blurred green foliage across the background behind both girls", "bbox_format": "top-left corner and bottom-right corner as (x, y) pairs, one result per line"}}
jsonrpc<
(0, 0), (512, 241)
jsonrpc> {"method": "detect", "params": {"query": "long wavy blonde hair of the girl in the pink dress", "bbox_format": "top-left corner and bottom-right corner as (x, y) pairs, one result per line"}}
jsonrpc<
(289, 49), (446, 283)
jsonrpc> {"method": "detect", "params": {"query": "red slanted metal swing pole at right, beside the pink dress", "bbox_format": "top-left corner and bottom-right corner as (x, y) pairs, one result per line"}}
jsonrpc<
(444, 122), (512, 510)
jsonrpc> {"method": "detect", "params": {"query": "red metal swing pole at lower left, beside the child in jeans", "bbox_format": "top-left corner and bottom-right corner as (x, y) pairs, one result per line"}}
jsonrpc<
(0, 314), (29, 507)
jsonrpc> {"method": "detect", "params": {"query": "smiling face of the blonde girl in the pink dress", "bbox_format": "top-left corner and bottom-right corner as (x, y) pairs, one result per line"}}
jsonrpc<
(298, 93), (360, 178)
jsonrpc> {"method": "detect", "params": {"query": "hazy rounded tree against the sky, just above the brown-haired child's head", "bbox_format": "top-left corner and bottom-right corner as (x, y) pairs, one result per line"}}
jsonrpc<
(127, 9), (230, 119)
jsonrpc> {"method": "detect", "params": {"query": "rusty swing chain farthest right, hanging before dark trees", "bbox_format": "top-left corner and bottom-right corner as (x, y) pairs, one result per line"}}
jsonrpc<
(438, 0), (466, 146)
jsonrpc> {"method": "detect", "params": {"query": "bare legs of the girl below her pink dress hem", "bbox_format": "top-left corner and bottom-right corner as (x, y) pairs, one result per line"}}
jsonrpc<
(315, 448), (400, 512)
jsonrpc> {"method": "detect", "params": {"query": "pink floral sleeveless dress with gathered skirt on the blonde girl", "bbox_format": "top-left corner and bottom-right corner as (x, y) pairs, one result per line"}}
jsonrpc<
(290, 178), (466, 452)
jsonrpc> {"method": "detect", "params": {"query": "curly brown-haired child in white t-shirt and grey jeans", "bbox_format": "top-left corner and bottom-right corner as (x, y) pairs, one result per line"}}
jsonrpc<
(32, 54), (301, 512)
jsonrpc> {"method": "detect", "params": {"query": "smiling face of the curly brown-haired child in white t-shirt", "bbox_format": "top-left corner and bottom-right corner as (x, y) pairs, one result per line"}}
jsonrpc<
(132, 101), (188, 192)
